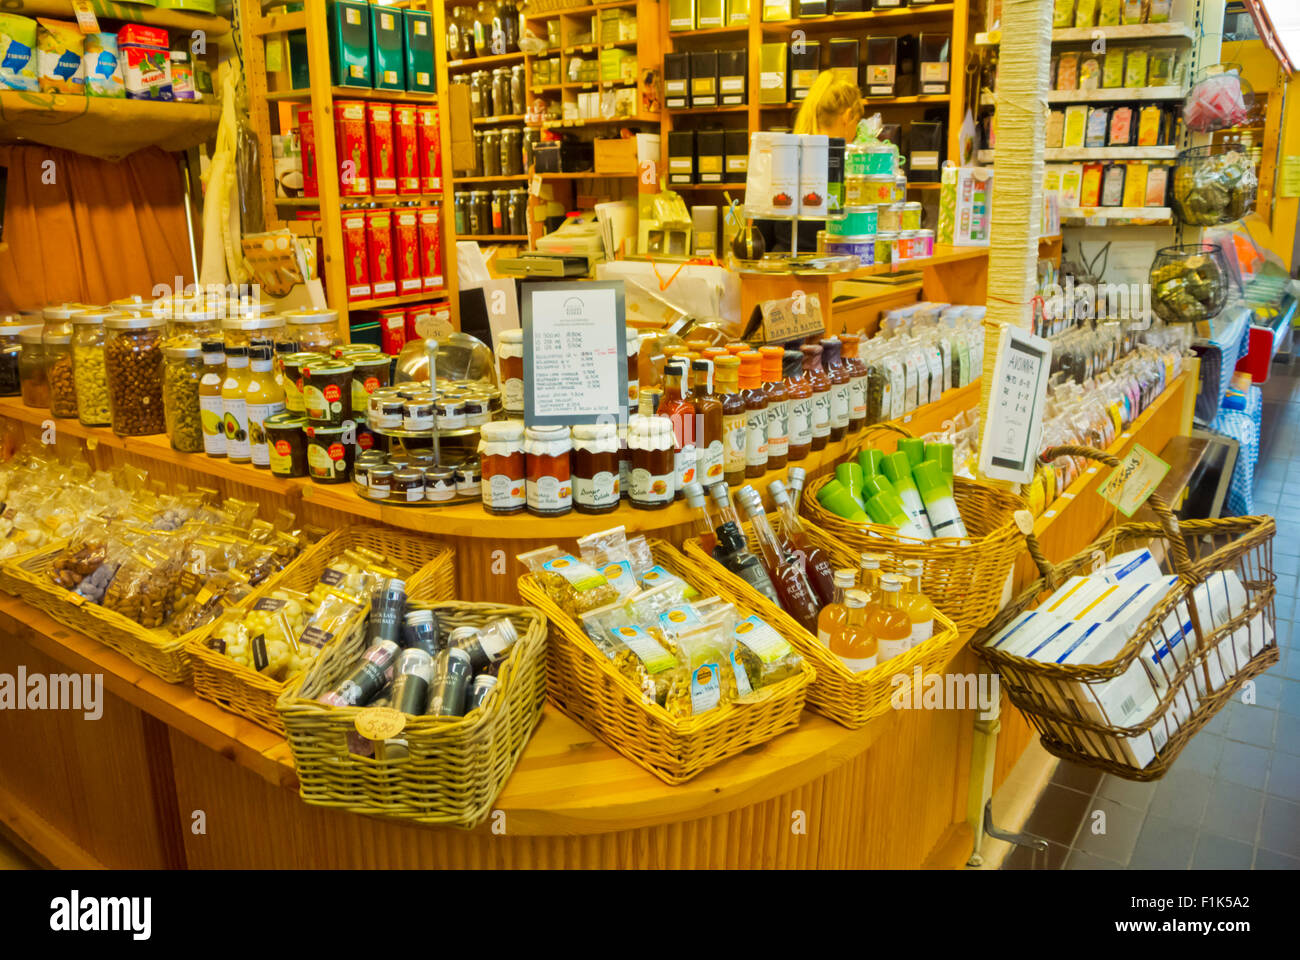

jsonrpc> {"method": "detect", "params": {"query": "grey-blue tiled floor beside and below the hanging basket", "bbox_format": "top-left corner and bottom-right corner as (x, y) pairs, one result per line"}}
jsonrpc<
(1002, 364), (1300, 870)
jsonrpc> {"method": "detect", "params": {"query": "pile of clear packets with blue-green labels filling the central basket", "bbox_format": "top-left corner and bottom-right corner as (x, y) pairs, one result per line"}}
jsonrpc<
(519, 527), (802, 717)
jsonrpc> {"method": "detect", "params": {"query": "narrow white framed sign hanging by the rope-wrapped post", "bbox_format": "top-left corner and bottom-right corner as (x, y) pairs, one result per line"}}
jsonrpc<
(979, 325), (1052, 484)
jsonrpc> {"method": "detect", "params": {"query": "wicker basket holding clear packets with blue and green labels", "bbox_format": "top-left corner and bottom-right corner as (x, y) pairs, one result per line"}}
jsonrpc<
(519, 540), (815, 783)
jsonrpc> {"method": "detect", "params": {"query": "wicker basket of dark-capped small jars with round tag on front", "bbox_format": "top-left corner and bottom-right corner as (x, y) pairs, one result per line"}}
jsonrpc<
(277, 594), (546, 827)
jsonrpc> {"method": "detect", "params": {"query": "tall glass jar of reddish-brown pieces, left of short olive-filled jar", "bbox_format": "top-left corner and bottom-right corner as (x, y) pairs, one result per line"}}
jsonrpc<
(104, 313), (166, 437)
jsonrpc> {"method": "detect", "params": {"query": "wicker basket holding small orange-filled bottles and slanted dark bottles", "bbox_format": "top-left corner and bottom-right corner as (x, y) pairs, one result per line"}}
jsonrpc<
(685, 514), (962, 728)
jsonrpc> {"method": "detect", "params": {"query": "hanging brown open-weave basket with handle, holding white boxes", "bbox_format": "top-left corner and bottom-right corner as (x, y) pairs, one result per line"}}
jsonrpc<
(972, 446), (1278, 780)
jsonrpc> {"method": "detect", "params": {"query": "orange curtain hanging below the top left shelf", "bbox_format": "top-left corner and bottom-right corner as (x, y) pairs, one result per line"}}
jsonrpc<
(0, 144), (194, 312)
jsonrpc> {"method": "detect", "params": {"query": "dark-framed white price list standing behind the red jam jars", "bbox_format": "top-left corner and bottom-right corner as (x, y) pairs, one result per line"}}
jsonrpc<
(523, 280), (628, 427)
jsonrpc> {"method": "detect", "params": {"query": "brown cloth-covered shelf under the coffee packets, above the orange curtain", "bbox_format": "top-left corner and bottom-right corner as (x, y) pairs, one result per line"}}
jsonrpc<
(0, 89), (221, 160)
